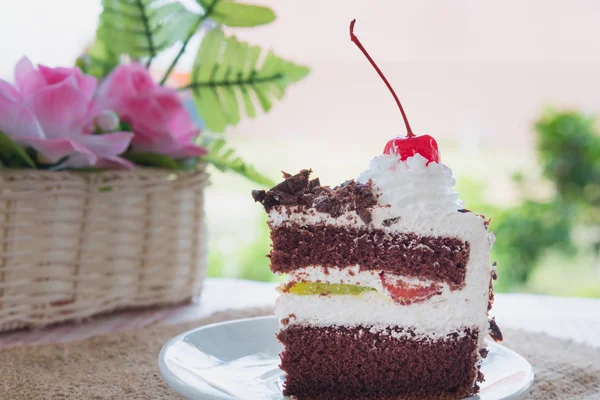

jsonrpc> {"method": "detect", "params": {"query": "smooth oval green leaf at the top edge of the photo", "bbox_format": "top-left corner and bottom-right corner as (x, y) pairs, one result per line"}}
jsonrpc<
(206, 0), (275, 26)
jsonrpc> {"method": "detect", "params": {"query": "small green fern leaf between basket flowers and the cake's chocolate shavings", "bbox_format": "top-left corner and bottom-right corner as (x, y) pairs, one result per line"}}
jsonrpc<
(200, 135), (275, 187)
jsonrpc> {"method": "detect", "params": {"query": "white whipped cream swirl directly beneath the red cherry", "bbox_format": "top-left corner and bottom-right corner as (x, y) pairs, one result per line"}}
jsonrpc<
(358, 154), (464, 215)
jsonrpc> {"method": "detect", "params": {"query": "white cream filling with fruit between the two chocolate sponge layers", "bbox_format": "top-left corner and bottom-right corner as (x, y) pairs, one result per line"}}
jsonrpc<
(276, 266), (490, 348)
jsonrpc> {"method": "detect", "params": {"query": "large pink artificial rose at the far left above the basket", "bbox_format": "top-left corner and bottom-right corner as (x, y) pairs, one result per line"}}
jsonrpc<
(0, 58), (133, 168)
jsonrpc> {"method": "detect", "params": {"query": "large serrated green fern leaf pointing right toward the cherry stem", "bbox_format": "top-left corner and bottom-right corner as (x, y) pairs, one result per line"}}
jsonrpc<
(189, 29), (309, 132)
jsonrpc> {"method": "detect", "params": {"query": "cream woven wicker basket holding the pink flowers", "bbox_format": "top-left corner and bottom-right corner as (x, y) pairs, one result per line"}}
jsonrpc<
(0, 165), (208, 332)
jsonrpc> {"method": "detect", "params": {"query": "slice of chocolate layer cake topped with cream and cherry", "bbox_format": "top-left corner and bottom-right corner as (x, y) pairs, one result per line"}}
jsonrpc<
(253, 19), (501, 399)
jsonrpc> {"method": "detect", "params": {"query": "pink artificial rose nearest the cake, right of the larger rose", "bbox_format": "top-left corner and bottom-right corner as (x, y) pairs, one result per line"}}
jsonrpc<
(96, 63), (206, 159)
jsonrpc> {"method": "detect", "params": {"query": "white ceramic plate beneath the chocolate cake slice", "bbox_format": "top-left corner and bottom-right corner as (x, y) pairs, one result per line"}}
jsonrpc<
(158, 317), (533, 400)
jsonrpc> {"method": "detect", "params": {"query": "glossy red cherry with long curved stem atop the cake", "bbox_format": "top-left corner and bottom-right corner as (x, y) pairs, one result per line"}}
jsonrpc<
(350, 19), (440, 164)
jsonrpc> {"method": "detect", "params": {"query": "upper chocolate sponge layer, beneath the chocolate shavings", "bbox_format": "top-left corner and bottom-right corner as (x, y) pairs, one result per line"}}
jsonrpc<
(269, 224), (470, 289)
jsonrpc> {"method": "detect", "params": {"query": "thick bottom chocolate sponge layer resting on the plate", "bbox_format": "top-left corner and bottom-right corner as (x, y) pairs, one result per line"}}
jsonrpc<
(278, 325), (483, 400)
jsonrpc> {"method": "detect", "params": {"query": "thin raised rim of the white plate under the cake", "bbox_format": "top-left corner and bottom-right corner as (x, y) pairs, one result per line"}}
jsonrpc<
(157, 315), (535, 400)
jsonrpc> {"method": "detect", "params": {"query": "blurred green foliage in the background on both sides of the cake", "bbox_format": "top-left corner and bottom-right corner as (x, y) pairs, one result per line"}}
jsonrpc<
(208, 109), (600, 297)
